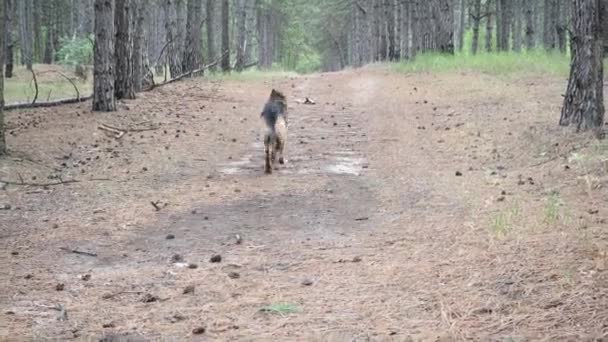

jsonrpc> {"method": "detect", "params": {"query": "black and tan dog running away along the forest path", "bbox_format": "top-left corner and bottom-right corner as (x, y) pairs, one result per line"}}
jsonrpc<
(261, 89), (287, 174)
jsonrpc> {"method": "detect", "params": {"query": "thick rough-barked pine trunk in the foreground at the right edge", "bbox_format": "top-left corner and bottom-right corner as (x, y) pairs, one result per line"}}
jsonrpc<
(559, 0), (608, 131)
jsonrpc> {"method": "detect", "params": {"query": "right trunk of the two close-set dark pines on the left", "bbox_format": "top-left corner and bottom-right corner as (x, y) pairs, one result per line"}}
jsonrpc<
(114, 0), (135, 99)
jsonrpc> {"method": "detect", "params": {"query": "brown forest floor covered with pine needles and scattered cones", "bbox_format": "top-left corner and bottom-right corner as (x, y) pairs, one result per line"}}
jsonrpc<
(0, 66), (608, 341)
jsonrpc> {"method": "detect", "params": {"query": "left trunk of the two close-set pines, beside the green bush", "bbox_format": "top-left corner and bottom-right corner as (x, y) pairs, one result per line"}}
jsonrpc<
(93, 0), (116, 112)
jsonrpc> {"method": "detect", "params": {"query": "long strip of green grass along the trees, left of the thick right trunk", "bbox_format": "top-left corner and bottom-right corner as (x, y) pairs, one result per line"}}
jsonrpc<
(393, 51), (570, 77)
